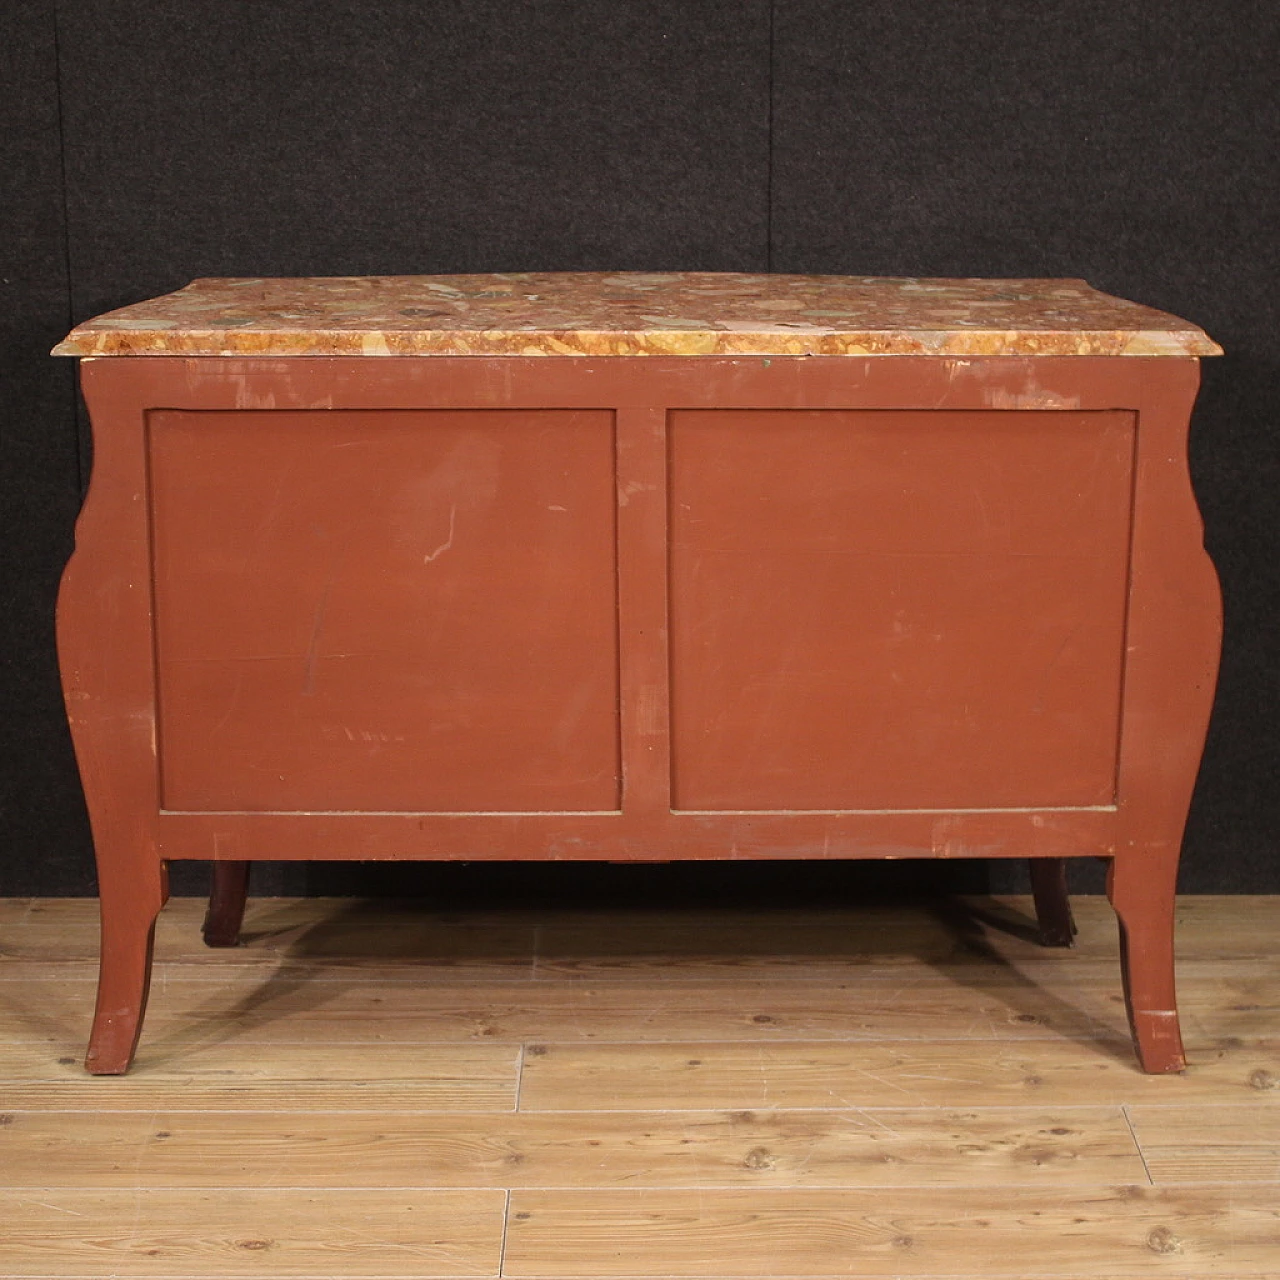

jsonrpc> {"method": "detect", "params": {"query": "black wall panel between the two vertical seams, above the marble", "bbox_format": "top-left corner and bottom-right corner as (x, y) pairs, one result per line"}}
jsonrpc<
(63, 0), (768, 315)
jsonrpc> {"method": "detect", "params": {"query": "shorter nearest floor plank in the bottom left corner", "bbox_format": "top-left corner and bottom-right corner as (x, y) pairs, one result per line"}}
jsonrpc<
(0, 1188), (506, 1280)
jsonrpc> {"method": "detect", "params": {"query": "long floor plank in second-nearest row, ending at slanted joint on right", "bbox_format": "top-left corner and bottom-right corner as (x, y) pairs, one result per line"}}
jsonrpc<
(0, 1107), (1147, 1188)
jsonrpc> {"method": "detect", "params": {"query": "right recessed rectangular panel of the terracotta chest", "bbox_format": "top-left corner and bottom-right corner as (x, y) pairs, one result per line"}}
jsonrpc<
(671, 411), (1134, 810)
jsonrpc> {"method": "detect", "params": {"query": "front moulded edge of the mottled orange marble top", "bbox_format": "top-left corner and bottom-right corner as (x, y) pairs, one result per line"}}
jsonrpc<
(50, 321), (1222, 358)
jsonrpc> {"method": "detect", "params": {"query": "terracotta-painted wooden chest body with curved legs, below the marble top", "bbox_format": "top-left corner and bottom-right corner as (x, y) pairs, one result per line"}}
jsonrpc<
(59, 356), (1220, 1073)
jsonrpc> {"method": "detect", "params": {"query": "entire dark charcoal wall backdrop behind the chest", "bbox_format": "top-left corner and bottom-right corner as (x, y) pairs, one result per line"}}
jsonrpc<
(0, 0), (1280, 900)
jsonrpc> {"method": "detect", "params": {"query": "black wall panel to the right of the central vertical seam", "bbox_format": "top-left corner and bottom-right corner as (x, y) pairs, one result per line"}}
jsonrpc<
(772, 0), (1280, 892)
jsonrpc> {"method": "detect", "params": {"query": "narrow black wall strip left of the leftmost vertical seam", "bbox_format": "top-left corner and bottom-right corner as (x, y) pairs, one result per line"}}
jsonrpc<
(0, 0), (93, 895)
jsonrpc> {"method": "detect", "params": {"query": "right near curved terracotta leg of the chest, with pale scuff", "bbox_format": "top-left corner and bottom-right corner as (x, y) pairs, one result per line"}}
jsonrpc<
(1107, 859), (1187, 1073)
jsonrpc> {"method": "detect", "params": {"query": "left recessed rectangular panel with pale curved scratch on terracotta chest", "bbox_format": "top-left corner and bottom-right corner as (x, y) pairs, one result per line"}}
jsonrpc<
(150, 410), (620, 812)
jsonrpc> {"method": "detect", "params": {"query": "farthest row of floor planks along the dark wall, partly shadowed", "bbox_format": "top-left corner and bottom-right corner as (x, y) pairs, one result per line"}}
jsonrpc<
(10, 895), (1280, 975)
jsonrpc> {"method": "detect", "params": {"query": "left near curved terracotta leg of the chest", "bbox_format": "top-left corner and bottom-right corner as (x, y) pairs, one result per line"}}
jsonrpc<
(84, 859), (169, 1075)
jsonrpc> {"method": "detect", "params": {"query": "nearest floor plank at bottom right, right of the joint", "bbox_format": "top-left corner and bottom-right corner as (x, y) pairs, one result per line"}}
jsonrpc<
(503, 1184), (1280, 1280)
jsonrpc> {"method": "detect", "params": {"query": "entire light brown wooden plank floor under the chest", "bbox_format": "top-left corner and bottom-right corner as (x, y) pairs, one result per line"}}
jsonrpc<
(0, 897), (1280, 1280)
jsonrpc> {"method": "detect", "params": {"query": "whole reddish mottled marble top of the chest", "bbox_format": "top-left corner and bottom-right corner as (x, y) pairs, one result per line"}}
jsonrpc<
(54, 271), (1221, 356)
